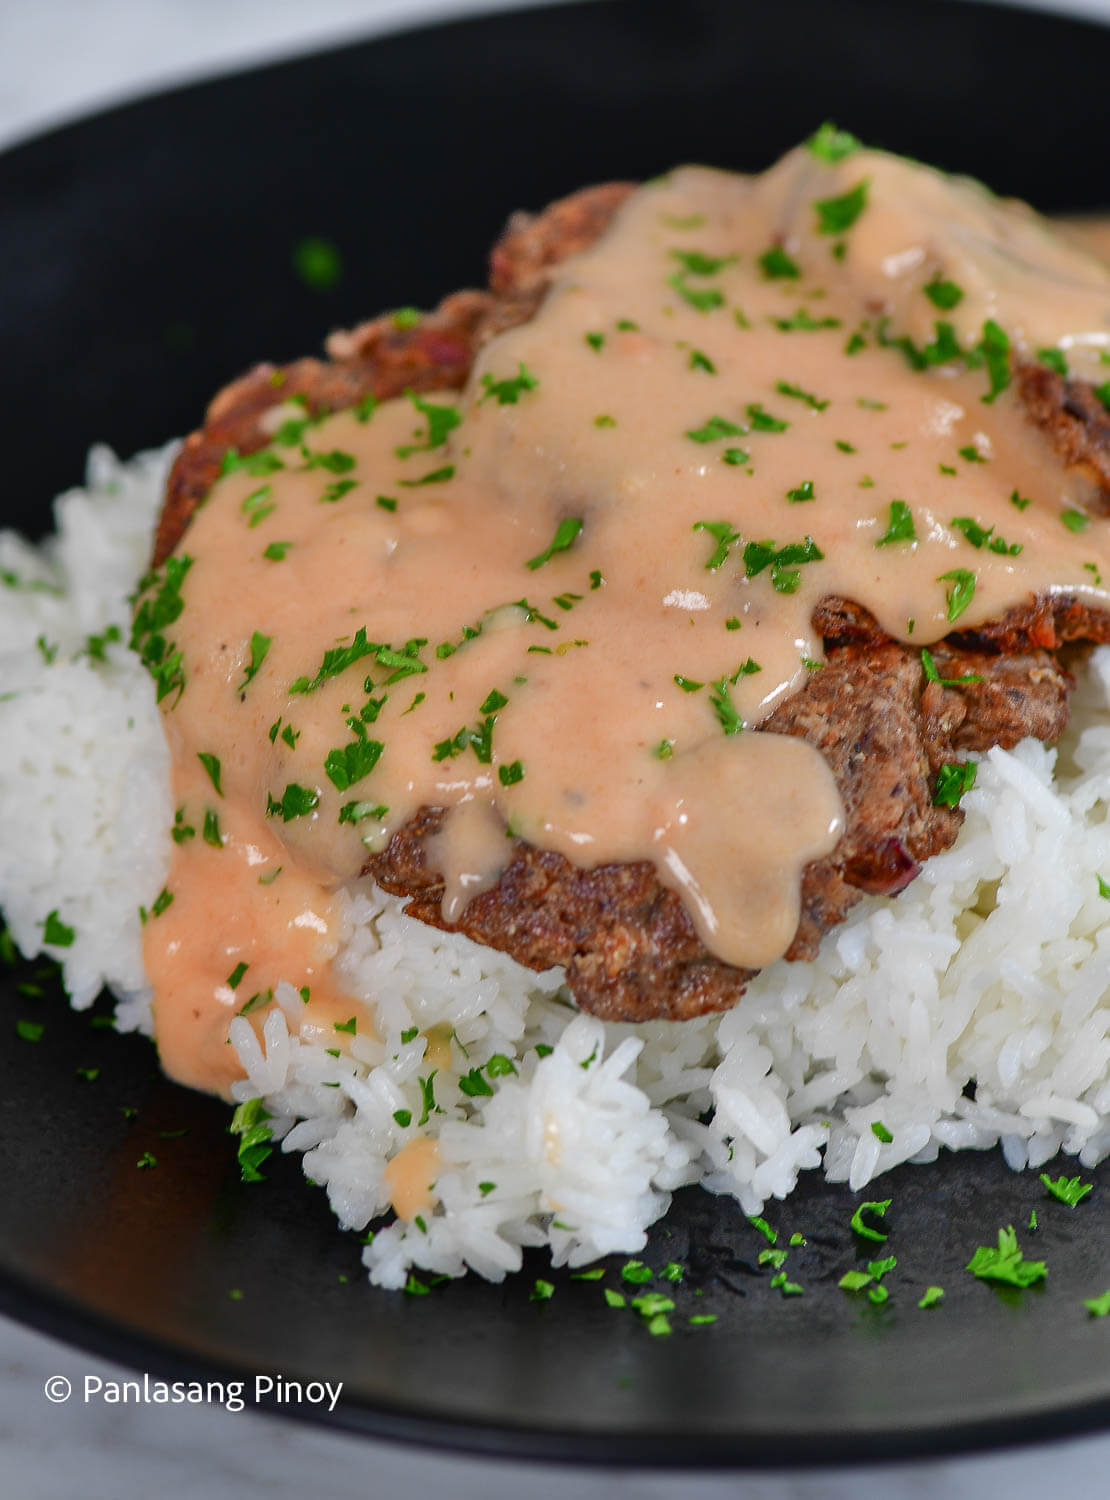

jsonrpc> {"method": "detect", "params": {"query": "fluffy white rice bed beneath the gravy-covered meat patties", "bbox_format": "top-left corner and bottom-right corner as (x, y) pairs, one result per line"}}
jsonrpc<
(0, 449), (1110, 1287)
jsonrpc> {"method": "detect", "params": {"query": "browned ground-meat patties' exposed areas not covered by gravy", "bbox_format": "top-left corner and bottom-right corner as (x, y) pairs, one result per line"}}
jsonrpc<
(155, 183), (1110, 1022)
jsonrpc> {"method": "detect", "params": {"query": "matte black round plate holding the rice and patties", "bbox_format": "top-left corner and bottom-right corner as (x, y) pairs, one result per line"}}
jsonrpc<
(0, 0), (1110, 1466)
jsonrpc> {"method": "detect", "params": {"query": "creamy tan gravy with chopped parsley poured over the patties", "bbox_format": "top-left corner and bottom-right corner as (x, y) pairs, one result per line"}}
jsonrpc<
(147, 150), (1110, 1089)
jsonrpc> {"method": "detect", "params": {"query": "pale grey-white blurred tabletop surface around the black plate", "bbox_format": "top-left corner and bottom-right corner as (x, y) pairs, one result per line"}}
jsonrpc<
(0, 0), (1110, 1500)
